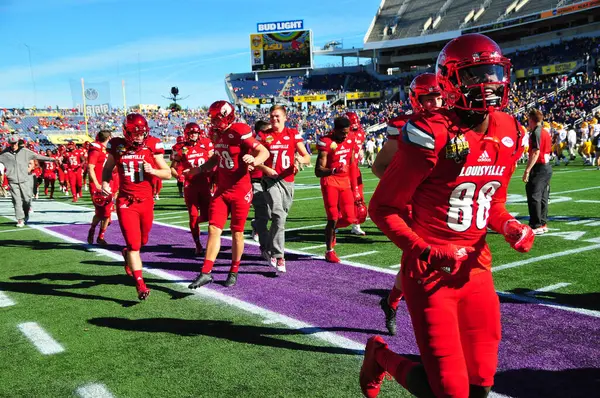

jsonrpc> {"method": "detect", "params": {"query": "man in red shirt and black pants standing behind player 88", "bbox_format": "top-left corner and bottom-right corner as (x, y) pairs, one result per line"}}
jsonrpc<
(523, 109), (552, 235)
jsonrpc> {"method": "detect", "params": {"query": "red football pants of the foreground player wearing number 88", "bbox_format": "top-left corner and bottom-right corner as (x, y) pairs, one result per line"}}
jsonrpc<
(402, 264), (501, 398)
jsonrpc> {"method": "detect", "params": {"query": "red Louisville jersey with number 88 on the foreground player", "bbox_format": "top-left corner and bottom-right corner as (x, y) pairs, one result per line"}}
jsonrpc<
(370, 110), (523, 277)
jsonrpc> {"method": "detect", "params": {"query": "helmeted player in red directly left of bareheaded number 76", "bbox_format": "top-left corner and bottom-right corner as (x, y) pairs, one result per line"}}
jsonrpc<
(186, 101), (269, 289)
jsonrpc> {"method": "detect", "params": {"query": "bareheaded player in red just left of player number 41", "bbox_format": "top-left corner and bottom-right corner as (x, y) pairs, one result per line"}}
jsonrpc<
(87, 130), (116, 245)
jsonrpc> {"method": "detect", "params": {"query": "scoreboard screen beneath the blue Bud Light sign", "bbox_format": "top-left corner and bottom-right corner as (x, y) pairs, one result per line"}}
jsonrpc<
(250, 30), (312, 72)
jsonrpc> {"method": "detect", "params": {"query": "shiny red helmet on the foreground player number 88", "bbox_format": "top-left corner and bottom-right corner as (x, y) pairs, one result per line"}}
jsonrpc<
(435, 33), (511, 112)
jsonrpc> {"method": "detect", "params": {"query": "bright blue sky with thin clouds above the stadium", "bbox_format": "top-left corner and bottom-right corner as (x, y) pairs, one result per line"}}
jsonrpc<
(0, 0), (380, 108)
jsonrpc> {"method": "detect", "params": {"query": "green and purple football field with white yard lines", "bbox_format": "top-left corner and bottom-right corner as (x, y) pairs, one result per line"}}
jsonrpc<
(0, 157), (600, 397)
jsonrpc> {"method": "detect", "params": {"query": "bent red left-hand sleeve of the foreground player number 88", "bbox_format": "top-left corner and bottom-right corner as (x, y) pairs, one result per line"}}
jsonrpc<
(369, 119), (437, 254)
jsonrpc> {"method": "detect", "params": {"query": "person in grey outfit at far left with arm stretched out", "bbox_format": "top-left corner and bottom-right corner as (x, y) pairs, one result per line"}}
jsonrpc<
(0, 135), (56, 228)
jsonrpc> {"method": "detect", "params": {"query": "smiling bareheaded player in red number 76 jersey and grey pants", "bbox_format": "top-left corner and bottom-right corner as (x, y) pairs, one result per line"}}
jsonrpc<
(254, 105), (310, 272)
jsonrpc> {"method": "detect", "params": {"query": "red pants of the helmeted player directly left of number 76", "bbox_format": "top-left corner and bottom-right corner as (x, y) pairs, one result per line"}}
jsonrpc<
(208, 186), (252, 232)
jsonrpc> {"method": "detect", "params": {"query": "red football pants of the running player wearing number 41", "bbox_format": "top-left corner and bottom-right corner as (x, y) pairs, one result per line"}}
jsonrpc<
(117, 197), (154, 251)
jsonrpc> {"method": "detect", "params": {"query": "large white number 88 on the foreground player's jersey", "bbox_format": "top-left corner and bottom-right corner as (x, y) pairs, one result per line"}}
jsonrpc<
(448, 181), (501, 232)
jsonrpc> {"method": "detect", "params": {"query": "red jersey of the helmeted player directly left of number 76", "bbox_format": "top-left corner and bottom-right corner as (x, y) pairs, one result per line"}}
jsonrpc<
(214, 123), (260, 191)
